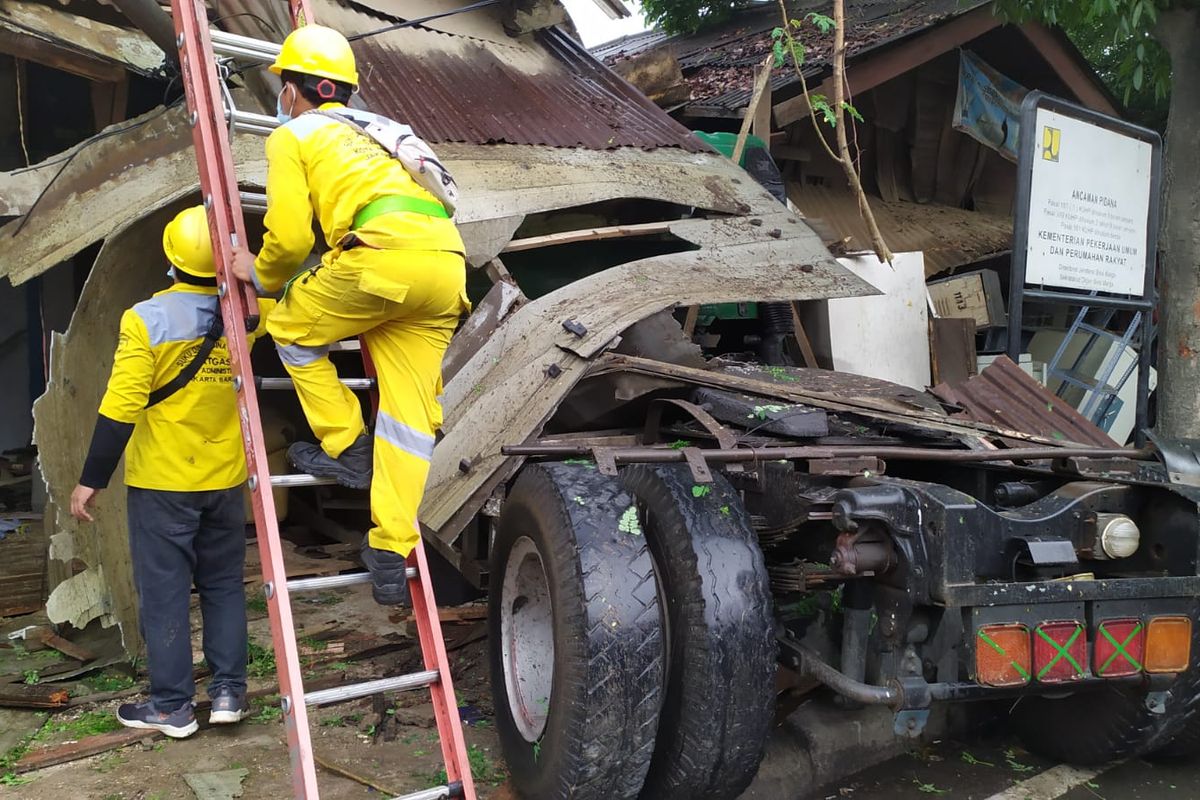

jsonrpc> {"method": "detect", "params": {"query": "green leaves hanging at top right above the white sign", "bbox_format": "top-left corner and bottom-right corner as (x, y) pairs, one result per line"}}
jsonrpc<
(996, 0), (1181, 130)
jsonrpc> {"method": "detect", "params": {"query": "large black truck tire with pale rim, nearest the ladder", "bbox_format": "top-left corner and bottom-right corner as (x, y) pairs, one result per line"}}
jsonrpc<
(488, 464), (665, 800)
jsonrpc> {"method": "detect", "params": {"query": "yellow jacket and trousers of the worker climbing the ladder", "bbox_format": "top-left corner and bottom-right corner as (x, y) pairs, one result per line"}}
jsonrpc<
(254, 103), (470, 555)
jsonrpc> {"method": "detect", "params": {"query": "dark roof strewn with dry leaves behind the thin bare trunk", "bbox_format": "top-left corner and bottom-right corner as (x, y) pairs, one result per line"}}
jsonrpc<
(592, 0), (983, 113)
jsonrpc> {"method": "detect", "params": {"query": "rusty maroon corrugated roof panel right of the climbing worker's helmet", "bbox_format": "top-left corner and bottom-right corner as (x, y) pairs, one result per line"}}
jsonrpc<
(355, 18), (708, 152)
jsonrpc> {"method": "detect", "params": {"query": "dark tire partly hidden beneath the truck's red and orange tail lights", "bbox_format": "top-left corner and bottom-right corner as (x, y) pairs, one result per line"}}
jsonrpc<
(1009, 625), (1200, 765)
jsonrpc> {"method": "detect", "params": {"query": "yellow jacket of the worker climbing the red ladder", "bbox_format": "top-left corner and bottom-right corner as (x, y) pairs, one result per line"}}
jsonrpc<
(254, 103), (464, 291)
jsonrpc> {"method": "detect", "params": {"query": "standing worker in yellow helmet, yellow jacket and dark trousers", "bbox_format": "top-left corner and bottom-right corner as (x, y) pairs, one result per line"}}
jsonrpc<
(71, 206), (274, 739)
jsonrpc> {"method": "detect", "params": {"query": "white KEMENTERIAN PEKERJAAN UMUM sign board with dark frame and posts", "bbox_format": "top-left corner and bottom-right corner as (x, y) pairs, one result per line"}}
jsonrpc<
(1008, 91), (1163, 446)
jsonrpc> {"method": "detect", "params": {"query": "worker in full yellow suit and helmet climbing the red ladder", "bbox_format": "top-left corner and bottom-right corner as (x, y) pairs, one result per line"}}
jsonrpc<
(234, 25), (469, 604)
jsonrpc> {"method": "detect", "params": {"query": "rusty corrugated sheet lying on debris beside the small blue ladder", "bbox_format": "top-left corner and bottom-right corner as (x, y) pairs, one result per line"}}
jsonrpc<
(932, 356), (1120, 447)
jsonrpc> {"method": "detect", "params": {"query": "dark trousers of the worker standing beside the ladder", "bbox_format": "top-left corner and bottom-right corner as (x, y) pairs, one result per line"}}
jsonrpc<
(128, 486), (246, 714)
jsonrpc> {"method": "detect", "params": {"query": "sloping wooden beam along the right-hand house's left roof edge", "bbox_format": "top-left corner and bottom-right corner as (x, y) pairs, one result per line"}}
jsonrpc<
(825, 5), (1001, 102)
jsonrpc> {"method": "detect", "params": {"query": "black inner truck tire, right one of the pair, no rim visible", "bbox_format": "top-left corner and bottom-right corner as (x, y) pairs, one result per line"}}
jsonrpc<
(622, 464), (778, 800)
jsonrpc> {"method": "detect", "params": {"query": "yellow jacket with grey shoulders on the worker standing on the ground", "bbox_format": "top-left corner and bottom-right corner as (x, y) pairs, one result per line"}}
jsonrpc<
(100, 283), (274, 492)
